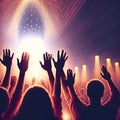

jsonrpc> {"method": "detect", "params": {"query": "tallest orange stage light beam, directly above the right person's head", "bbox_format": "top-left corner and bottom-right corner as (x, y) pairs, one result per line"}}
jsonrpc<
(94, 55), (101, 79)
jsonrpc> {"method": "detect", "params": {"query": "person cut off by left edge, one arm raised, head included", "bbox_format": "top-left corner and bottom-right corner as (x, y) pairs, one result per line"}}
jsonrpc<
(0, 49), (14, 120)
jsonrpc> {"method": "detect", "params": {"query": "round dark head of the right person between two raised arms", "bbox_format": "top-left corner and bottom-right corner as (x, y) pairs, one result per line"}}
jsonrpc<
(87, 80), (104, 104)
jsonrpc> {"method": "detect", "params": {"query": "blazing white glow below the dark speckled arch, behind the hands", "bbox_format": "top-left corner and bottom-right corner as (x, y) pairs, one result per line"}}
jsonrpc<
(17, 36), (45, 79)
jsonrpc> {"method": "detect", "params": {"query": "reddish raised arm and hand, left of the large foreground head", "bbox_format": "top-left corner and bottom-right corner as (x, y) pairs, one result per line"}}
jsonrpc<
(4, 52), (29, 120)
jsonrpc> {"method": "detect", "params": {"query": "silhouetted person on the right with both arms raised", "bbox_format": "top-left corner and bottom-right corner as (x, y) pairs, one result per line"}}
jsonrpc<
(63, 66), (119, 120)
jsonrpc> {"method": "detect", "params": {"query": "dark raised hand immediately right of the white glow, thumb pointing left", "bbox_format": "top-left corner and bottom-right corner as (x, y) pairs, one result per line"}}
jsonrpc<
(40, 52), (52, 71)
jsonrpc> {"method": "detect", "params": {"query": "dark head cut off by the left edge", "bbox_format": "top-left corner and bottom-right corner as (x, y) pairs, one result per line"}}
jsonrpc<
(0, 87), (9, 116)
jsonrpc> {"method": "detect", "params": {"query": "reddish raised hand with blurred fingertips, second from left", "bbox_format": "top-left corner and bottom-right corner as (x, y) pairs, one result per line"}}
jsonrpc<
(17, 52), (29, 72)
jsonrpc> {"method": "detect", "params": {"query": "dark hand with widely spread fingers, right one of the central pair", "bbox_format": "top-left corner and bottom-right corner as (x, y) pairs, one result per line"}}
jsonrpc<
(53, 50), (68, 70)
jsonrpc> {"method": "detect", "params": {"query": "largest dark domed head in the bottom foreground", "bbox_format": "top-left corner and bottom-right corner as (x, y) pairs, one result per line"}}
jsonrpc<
(16, 86), (55, 120)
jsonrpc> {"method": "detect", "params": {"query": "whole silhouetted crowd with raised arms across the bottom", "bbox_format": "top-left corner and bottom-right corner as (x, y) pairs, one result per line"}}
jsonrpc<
(0, 49), (120, 120)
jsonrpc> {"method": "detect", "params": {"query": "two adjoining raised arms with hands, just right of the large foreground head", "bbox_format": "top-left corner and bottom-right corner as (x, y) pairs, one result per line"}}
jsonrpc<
(40, 50), (68, 120)
